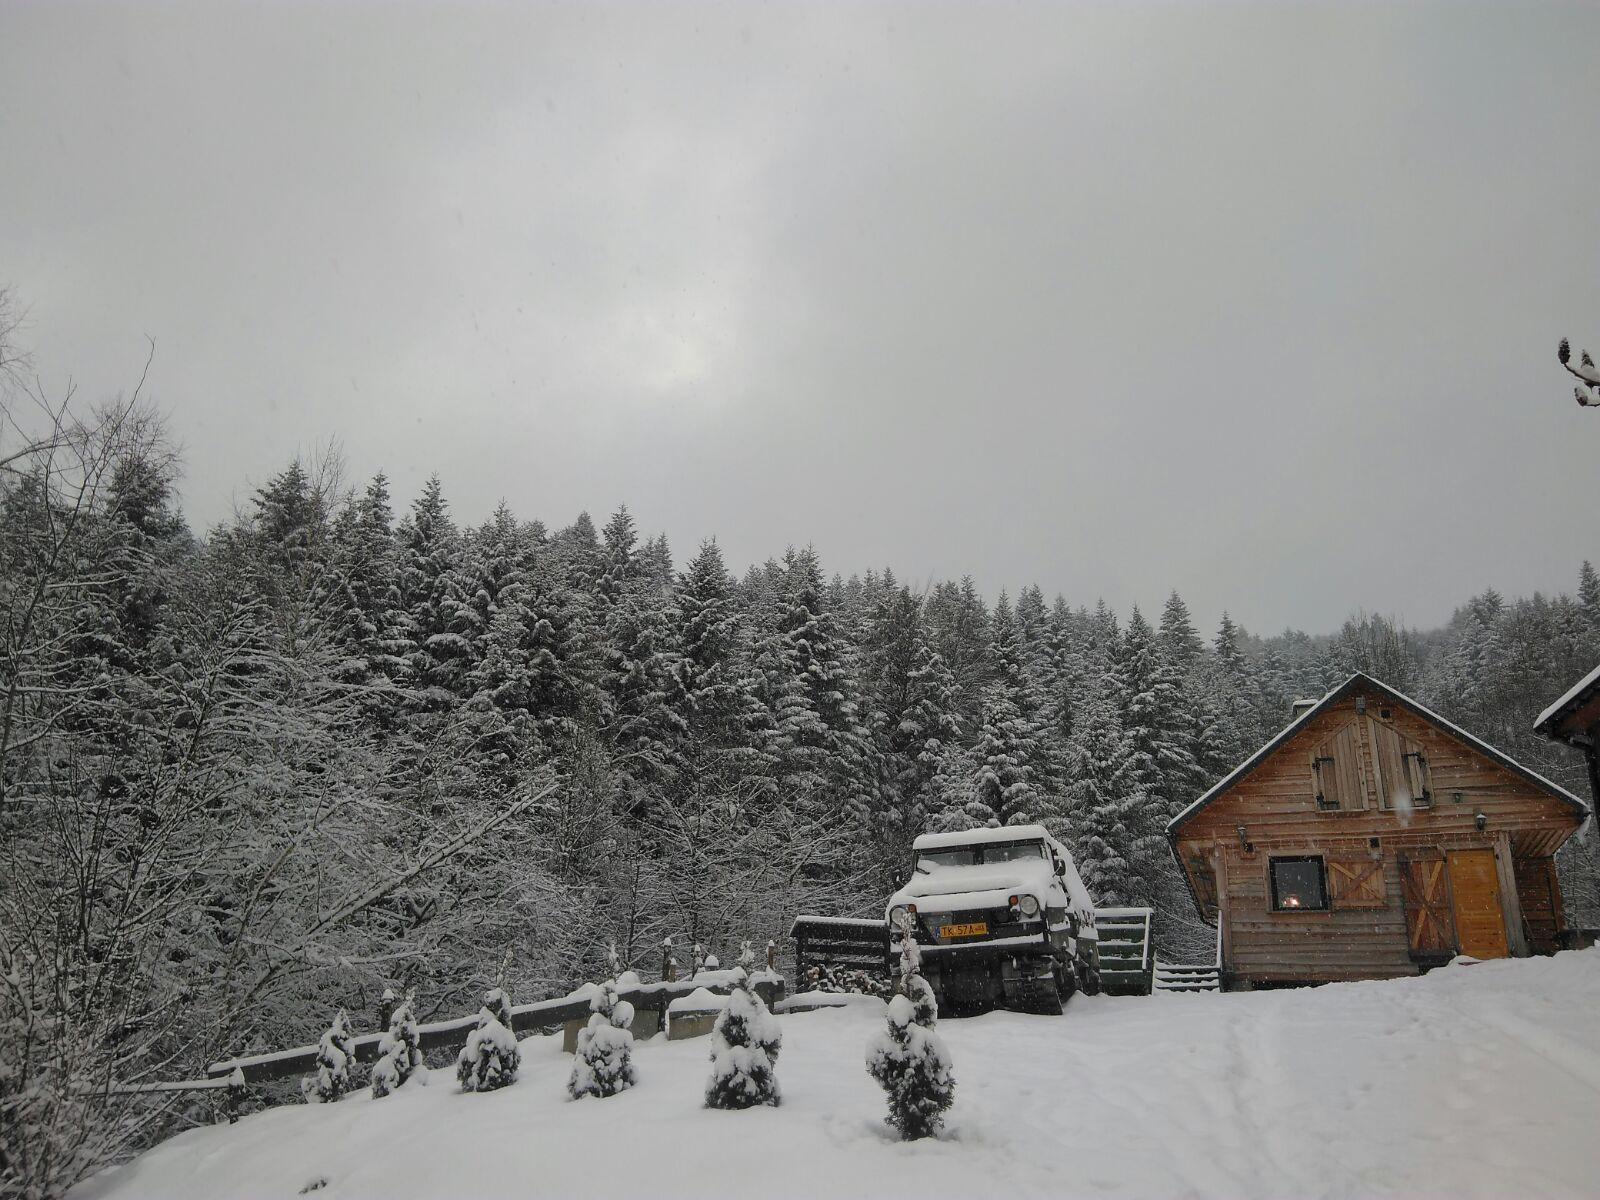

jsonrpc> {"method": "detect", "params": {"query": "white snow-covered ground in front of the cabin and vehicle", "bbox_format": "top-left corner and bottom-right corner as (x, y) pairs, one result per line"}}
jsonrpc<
(72, 950), (1600, 1200)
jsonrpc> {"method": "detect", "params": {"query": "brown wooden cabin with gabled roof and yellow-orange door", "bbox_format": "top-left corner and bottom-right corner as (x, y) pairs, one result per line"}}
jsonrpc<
(1166, 675), (1589, 987)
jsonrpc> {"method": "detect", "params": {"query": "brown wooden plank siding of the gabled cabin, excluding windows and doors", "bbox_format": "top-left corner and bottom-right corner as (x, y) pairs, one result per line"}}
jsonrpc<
(1174, 691), (1579, 982)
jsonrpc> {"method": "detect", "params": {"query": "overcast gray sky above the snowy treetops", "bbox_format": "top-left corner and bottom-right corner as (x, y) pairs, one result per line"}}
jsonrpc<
(0, 0), (1600, 632)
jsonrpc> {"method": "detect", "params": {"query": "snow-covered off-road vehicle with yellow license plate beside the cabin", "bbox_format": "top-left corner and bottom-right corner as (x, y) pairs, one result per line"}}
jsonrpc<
(885, 826), (1099, 1016)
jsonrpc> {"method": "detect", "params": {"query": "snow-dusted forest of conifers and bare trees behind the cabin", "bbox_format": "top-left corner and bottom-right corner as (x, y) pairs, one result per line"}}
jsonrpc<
(0, 392), (1600, 1179)
